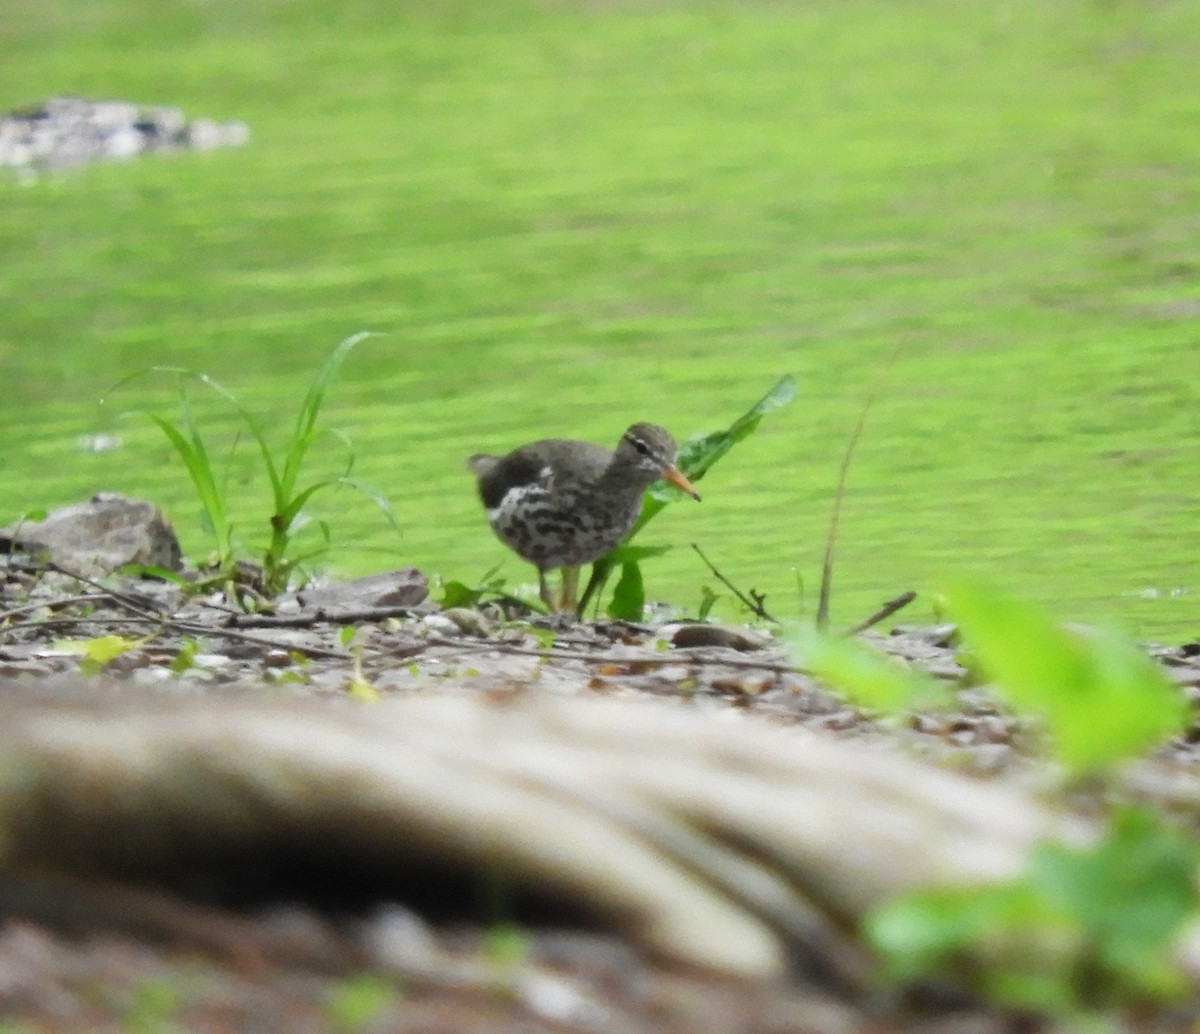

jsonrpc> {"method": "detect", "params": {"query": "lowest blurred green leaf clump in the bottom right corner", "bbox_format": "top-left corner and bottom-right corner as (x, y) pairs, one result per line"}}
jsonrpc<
(866, 808), (1200, 1030)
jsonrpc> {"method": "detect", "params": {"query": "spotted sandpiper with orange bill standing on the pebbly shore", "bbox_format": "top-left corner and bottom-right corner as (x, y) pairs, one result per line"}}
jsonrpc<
(467, 423), (700, 613)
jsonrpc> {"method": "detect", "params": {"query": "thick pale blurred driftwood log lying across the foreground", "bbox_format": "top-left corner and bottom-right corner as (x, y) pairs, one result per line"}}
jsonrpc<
(0, 683), (1088, 981)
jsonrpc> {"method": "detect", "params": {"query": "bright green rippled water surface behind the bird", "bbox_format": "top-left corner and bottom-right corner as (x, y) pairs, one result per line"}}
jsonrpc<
(0, 0), (1200, 642)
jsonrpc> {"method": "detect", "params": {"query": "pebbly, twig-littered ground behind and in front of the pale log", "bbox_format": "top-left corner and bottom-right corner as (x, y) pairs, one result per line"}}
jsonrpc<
(0, 565), (1200, 1034)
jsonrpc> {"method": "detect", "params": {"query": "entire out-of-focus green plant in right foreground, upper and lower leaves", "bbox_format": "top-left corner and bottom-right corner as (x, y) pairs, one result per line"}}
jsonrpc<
(798, 578), (1200, 1030)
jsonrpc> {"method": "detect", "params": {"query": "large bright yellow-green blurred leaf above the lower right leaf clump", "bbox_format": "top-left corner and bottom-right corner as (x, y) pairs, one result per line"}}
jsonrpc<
(946, 579), (1188, 774)
